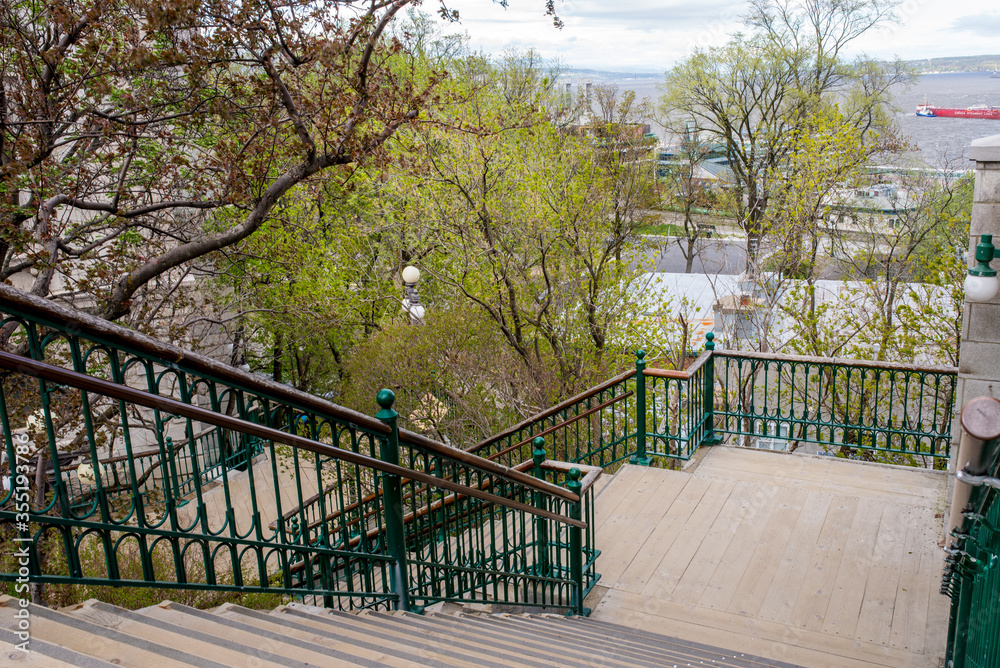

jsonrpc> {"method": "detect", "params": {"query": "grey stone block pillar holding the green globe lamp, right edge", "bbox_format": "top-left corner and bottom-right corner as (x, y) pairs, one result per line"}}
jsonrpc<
(953, 135), (1000, 412)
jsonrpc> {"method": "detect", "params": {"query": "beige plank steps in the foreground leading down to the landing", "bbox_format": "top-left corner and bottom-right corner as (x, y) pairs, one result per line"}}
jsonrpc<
(0, 597), (791, 668)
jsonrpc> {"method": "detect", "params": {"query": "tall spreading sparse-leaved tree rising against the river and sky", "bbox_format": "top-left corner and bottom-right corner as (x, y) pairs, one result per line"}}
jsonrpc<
(661, 0), (910, 269)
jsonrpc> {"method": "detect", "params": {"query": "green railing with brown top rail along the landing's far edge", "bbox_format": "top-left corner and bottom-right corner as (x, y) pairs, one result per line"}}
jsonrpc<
(471, 332), (958, 470)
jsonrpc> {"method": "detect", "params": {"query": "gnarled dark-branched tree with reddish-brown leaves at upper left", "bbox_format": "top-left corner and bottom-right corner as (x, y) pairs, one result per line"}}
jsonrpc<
(0, 0), (558, 319)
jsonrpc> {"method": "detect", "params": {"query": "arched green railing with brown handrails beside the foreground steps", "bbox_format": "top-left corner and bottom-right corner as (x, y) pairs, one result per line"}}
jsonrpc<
(0, 286), (596, 612)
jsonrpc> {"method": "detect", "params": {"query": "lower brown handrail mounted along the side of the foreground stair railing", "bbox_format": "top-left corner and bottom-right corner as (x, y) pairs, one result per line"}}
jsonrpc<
(0, 351), (586, 528)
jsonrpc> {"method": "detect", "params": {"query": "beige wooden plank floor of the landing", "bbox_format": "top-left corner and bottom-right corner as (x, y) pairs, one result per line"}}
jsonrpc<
(592, 447), (948, 668)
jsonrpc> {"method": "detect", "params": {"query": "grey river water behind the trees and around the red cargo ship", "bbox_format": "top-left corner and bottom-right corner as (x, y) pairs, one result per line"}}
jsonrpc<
(613, 72), (1000, 169)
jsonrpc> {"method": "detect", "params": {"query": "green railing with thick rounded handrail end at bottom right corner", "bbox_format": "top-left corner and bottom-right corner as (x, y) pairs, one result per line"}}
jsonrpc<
(941, 397), (1000, 668)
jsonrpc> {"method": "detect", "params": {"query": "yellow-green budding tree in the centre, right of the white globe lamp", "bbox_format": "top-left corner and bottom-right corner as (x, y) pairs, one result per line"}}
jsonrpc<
(402, 78), (652, 395)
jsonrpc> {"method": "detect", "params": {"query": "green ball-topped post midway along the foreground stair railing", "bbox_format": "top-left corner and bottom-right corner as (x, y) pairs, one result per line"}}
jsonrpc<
(375, 390), (410, 611)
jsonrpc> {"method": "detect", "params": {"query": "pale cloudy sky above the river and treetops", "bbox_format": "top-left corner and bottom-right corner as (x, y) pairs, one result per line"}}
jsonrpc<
(450, 0), (1000, 72)
